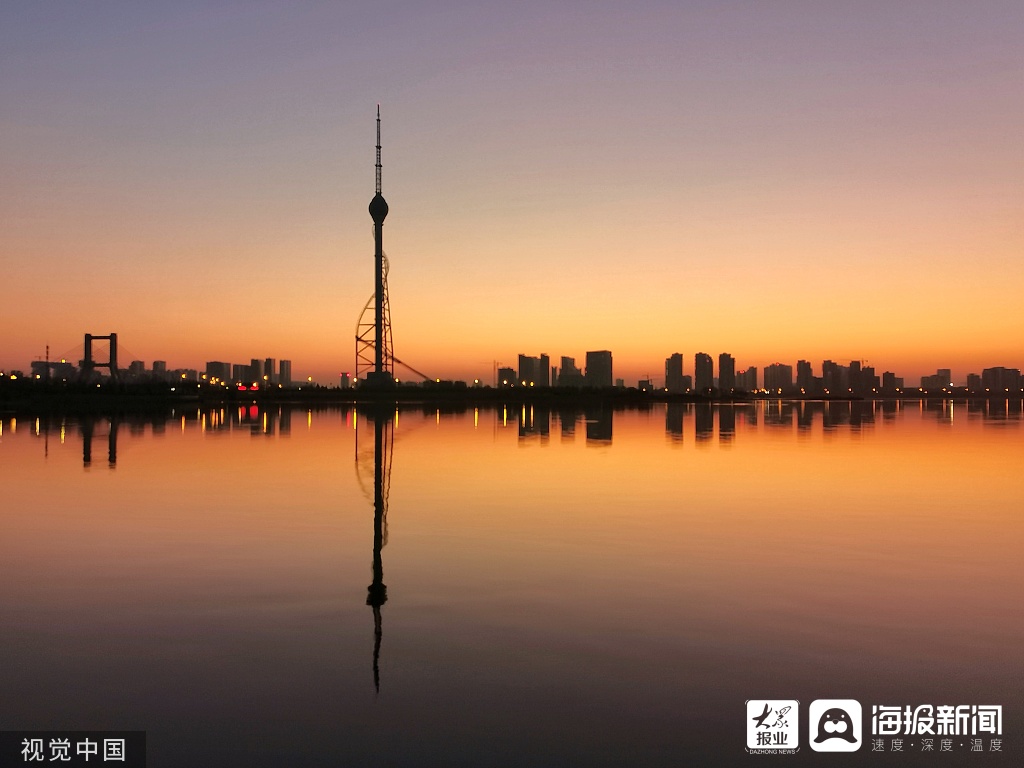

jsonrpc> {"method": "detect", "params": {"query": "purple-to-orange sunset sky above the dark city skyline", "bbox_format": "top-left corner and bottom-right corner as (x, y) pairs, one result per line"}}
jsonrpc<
(0, 0), (1024, 383)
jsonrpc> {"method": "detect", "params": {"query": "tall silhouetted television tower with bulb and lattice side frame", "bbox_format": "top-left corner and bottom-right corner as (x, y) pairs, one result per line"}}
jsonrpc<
(355, 104), (394, 389)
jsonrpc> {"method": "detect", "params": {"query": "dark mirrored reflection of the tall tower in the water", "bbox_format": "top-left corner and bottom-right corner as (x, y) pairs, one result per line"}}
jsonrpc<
(355, 406), (398, 692)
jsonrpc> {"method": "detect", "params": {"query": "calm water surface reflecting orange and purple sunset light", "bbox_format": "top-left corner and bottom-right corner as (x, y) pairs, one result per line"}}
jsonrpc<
(0, 401), (1024, 766)
